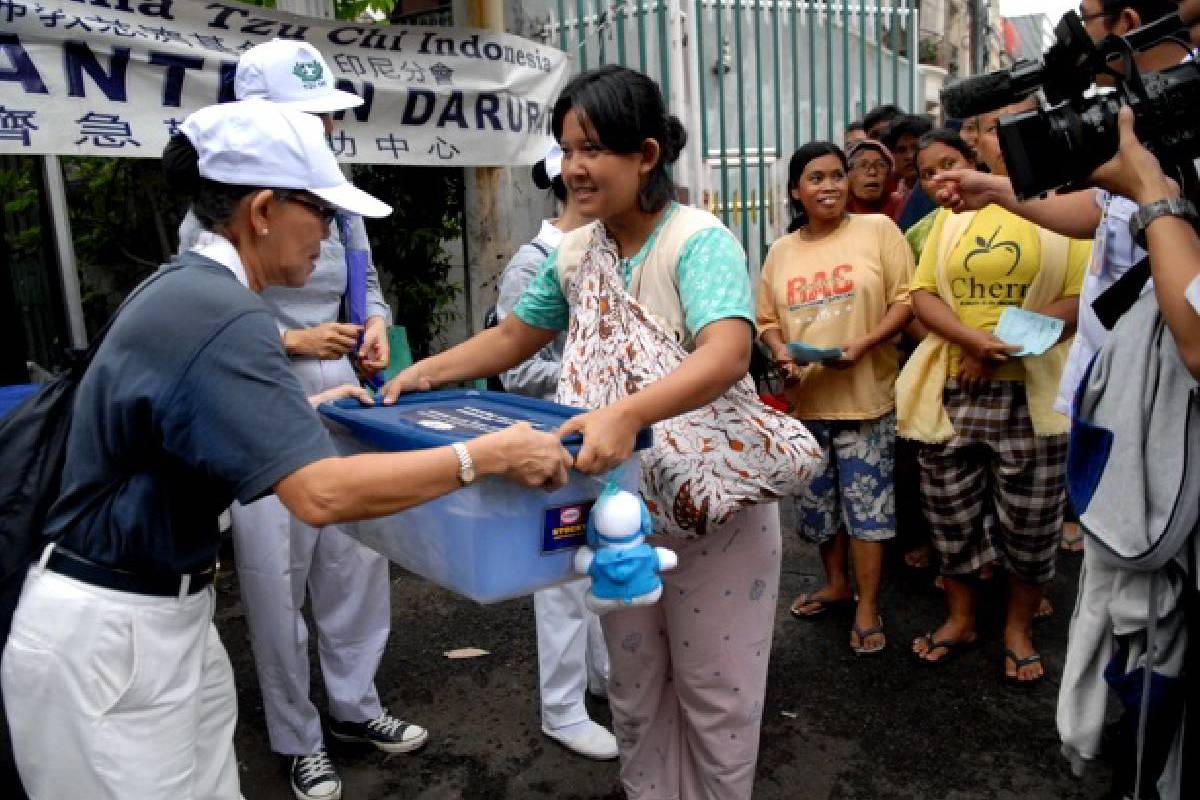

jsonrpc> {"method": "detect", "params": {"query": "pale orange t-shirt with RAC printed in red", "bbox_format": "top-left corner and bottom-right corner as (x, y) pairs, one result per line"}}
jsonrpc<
(758, 213), (913, 420)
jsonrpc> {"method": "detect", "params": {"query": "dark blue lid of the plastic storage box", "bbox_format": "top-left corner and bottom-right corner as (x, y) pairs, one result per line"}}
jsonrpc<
(320, 389), (653, 455)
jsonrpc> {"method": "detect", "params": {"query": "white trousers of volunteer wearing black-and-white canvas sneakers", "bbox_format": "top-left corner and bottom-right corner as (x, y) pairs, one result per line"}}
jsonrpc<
(232, 359), (391, 756)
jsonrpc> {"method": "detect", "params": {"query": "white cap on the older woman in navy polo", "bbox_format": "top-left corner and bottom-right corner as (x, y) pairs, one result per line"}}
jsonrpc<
(180, 100), (391, 217)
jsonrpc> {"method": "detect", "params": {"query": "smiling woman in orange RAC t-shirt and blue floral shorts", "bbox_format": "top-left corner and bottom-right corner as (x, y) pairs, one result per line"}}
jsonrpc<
(758, 140), (912, 655)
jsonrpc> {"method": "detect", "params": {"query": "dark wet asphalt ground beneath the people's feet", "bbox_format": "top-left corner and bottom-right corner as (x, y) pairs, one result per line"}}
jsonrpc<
(218, 503), (1109, 800)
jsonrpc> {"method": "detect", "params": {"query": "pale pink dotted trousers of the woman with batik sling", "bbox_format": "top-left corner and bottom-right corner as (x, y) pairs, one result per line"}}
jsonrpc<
(601, 504), (782, 800)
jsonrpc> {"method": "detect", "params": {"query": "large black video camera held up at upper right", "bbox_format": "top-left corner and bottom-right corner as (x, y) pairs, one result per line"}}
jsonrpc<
(942, 11), (1200, 199)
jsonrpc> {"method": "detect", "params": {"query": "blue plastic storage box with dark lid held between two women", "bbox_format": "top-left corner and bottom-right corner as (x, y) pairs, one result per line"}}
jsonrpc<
(320, 391), (650, 603)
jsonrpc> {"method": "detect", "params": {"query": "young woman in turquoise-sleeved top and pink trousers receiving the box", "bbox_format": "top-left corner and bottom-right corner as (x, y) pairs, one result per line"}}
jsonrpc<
(384, 66), (780, 800)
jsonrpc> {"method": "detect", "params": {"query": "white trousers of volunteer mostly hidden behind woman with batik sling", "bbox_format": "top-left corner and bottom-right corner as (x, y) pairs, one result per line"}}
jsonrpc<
(533, 579), (608, 730)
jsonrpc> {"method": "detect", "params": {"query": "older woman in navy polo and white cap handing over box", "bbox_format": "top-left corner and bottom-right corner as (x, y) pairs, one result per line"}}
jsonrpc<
(0, 100), (570, 800)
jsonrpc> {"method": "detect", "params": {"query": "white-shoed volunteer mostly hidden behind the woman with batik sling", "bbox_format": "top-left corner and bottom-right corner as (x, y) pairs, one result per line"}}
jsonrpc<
(496, 144), (617, 760)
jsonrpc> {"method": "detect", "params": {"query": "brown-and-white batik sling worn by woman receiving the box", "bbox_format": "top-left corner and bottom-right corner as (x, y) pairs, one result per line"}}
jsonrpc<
(558, 206), (820, 539)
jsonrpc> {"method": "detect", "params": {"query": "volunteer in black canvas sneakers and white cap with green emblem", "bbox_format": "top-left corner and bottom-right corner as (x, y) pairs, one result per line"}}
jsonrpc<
(179, 38), (408, 800)
